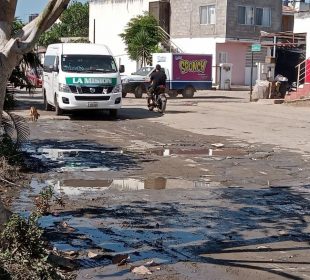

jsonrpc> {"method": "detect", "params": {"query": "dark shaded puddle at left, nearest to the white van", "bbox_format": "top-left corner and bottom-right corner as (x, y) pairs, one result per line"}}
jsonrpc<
(23, 141), (138, 172)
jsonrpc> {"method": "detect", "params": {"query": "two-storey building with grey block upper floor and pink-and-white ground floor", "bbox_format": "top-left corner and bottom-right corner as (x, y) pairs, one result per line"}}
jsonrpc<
(170, 0), (282, 85)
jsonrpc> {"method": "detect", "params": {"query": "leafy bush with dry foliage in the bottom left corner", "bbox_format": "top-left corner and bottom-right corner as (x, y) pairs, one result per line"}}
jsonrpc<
(0, 213), (64, 280)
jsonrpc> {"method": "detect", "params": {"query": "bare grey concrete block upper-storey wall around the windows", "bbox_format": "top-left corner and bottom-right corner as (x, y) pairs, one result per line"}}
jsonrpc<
(170, 0), (282, 39)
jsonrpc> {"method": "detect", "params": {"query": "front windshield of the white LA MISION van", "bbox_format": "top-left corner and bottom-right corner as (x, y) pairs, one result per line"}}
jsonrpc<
(61, 54), (117, 73)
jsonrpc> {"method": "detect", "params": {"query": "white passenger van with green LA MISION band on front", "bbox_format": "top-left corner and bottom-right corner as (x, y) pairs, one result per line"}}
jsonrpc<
(43, 43), (124, 117)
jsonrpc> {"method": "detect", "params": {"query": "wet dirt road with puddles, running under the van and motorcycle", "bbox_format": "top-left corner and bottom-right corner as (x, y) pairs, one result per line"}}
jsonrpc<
(13, 91), (310, 279)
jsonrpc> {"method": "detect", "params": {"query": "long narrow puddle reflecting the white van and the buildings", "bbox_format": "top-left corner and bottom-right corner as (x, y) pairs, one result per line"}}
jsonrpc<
(13, 177), (211, 211)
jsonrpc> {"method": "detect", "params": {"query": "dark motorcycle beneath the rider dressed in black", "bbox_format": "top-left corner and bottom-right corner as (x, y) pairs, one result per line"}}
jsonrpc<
(147, 86), (167, 114)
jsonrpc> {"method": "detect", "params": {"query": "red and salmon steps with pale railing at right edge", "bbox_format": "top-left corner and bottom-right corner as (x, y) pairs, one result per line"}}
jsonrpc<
(285, 58), (310, 102)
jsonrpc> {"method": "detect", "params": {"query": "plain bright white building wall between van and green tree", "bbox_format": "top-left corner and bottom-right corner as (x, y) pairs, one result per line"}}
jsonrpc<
(89, 0), (151, 73)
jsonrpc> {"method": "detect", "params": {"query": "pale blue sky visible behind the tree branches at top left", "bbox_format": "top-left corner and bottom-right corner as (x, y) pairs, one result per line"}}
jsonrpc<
(15, 0), (86, 23)
